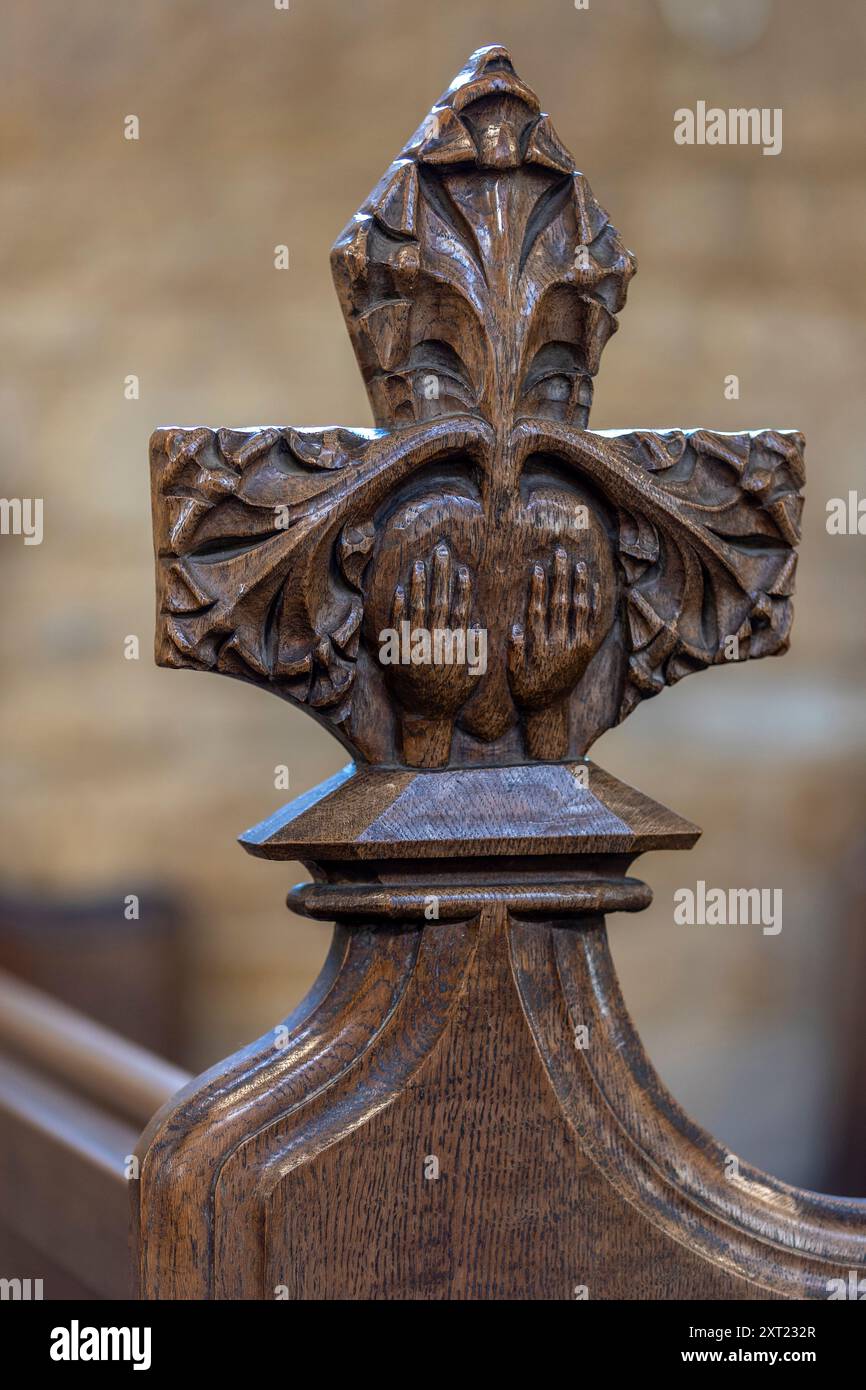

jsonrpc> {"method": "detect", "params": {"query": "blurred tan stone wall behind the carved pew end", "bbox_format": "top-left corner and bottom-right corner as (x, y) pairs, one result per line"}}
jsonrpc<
(0, 0), (866, 1186)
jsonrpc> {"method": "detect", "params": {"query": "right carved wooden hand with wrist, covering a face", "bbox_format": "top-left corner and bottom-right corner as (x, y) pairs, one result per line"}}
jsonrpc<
(507, 546), (601, 758)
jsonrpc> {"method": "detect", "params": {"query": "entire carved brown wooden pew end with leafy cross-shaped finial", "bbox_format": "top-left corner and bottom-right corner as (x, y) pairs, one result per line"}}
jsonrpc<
(135, 47), (866, 1300)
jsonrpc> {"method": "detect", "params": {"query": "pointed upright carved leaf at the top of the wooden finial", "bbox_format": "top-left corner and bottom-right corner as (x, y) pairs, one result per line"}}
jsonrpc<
(332, 47), (635, 428)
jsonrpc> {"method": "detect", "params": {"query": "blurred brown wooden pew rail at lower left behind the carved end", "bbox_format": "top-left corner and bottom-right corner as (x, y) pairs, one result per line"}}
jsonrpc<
(0, 972), (189, 1298)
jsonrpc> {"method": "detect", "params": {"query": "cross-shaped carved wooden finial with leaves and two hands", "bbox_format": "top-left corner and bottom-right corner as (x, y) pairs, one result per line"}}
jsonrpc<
(152, 47), (803, 766)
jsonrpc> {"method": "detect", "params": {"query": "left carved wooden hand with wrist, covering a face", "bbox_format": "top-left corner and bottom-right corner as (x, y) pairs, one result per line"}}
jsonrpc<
(379, 541), (487, 767)
